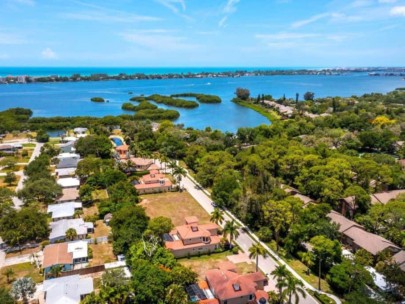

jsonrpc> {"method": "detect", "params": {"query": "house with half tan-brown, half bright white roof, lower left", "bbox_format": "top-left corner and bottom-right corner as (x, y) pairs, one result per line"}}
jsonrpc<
(42, 241), (88, 277)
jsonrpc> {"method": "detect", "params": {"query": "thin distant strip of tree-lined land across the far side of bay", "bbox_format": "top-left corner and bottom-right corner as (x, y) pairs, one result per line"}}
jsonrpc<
(0, 67), (405, 84)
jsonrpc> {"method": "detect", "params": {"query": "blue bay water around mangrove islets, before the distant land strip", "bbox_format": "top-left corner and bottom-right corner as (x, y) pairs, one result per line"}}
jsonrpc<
(0, 68), (405, 132)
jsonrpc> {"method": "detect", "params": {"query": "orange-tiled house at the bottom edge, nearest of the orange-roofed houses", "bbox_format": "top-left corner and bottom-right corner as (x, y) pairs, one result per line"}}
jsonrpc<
(204, 263), (268, 304)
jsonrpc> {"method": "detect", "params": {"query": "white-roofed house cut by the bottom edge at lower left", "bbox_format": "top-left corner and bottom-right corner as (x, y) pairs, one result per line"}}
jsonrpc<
(43, 274), (94, 304)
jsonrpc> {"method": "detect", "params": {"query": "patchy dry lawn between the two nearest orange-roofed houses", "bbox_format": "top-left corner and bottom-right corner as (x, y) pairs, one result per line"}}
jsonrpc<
(178, 251), (256, 280)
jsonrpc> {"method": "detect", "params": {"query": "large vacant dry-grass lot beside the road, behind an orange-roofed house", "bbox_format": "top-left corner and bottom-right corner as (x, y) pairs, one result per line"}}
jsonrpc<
(141, 191), (210, 226)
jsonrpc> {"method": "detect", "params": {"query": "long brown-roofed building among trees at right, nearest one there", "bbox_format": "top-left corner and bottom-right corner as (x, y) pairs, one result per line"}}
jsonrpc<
(327, 211), (400, 256)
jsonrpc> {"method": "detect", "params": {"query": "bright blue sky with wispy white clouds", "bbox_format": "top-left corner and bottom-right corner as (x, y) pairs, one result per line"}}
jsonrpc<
(0, 0), (405, 67)
